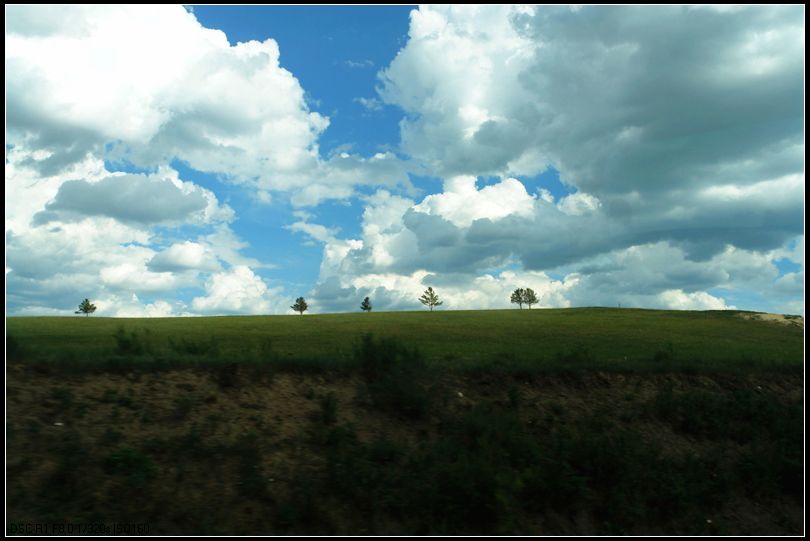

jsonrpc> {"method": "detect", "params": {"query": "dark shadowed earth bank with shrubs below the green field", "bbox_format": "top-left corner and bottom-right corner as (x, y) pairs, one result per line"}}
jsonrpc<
(6, 313), (804, 535)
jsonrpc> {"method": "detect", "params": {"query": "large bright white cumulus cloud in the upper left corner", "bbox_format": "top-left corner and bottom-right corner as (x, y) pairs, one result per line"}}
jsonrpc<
(6, 5), (408, 205)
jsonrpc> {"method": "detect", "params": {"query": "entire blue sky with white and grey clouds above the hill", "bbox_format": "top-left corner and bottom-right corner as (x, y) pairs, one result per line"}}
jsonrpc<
(5, 5), (804, 317)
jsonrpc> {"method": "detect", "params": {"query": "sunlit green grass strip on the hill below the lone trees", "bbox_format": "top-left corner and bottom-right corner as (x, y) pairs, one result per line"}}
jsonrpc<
(6, 308), (804, 371)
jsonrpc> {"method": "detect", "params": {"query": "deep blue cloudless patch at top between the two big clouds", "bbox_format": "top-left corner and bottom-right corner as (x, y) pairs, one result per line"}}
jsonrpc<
(193, 6), (414, 154)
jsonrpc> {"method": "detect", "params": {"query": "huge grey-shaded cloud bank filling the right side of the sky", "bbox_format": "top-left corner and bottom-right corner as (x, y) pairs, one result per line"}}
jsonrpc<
(304, 6), (804, 311)
